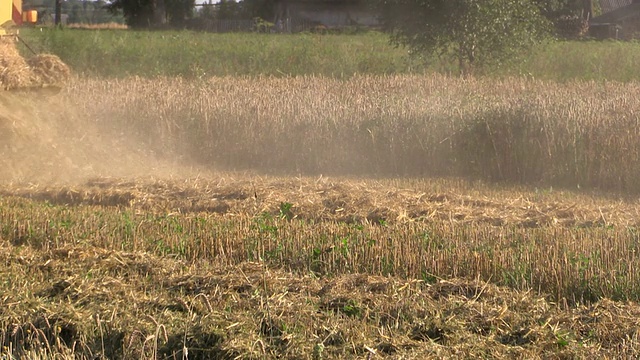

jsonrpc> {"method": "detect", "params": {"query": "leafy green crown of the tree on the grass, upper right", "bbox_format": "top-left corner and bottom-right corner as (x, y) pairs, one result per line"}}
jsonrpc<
(381, 0), (549, 73)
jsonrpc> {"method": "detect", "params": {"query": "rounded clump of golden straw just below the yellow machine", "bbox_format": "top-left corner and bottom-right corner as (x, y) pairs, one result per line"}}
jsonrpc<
(0, 39), (70, 90)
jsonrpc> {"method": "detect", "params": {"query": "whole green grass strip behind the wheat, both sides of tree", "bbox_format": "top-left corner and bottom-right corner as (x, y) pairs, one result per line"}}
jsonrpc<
(13, 29), (640, 82)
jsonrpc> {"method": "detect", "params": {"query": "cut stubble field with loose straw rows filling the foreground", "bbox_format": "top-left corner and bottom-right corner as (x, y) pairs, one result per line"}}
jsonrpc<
(0, 174), (640, 359)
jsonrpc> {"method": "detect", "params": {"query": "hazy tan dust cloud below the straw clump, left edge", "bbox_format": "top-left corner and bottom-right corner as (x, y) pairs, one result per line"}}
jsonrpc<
(0, 89), (201, 185)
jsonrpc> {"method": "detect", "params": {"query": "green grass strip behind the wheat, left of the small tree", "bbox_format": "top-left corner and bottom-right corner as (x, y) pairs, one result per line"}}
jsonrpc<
(18, 29), (414, 78)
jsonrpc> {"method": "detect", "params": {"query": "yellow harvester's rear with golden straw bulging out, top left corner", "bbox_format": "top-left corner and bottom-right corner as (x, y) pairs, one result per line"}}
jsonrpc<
(0, 0), (70, 92)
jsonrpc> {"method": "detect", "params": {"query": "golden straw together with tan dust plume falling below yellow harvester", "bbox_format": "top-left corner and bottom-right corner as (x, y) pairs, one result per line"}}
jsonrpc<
(0, 37), (200, 184)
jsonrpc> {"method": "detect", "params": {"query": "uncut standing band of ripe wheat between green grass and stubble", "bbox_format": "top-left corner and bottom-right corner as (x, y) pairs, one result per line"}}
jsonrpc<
(62, 75), (640, 193)
